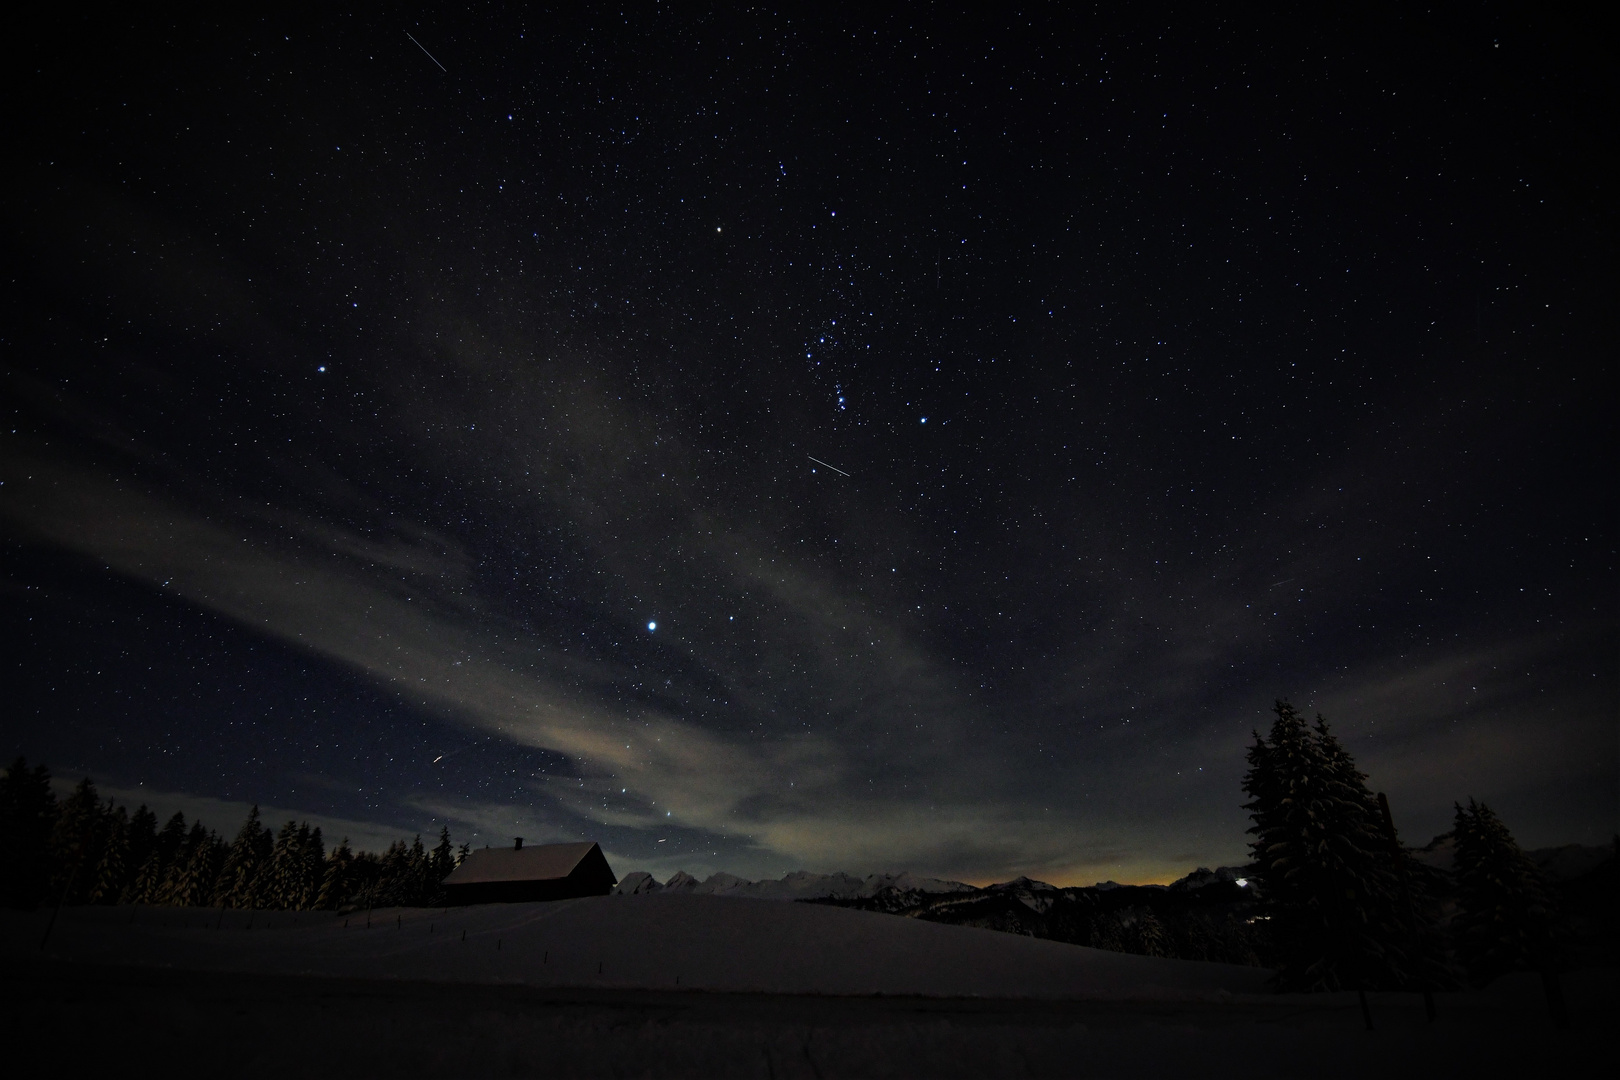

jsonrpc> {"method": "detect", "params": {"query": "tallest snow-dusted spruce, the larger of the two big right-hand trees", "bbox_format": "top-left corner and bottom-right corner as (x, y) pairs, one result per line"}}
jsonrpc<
(1243, 701), (1409, 989)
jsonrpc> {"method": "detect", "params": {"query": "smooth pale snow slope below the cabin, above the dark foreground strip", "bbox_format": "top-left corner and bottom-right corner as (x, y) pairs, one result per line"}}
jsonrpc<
(0, 894), (1268, 1001)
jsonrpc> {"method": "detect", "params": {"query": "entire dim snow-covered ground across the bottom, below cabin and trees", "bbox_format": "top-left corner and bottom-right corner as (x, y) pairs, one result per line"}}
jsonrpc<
(0, 889), (1617, 1080)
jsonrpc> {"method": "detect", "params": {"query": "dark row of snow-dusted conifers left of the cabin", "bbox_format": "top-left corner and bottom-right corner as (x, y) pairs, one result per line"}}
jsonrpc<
(0, 758), (468, 912)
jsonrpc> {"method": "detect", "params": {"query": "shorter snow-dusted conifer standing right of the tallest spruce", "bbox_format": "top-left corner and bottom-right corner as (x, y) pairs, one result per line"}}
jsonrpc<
(1452, 798), (1554, 986)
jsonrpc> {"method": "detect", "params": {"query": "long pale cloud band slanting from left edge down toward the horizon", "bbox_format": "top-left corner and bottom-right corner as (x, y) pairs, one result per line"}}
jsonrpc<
(5, 440), (1049, 865)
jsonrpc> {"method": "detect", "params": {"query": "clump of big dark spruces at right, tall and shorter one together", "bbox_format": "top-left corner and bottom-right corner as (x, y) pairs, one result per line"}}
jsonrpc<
(1243, 701), (1558, 996)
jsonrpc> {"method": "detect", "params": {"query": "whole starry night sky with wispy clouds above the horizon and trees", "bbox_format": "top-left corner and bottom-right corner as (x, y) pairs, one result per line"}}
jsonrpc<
(0, 5), (1620, 884)
